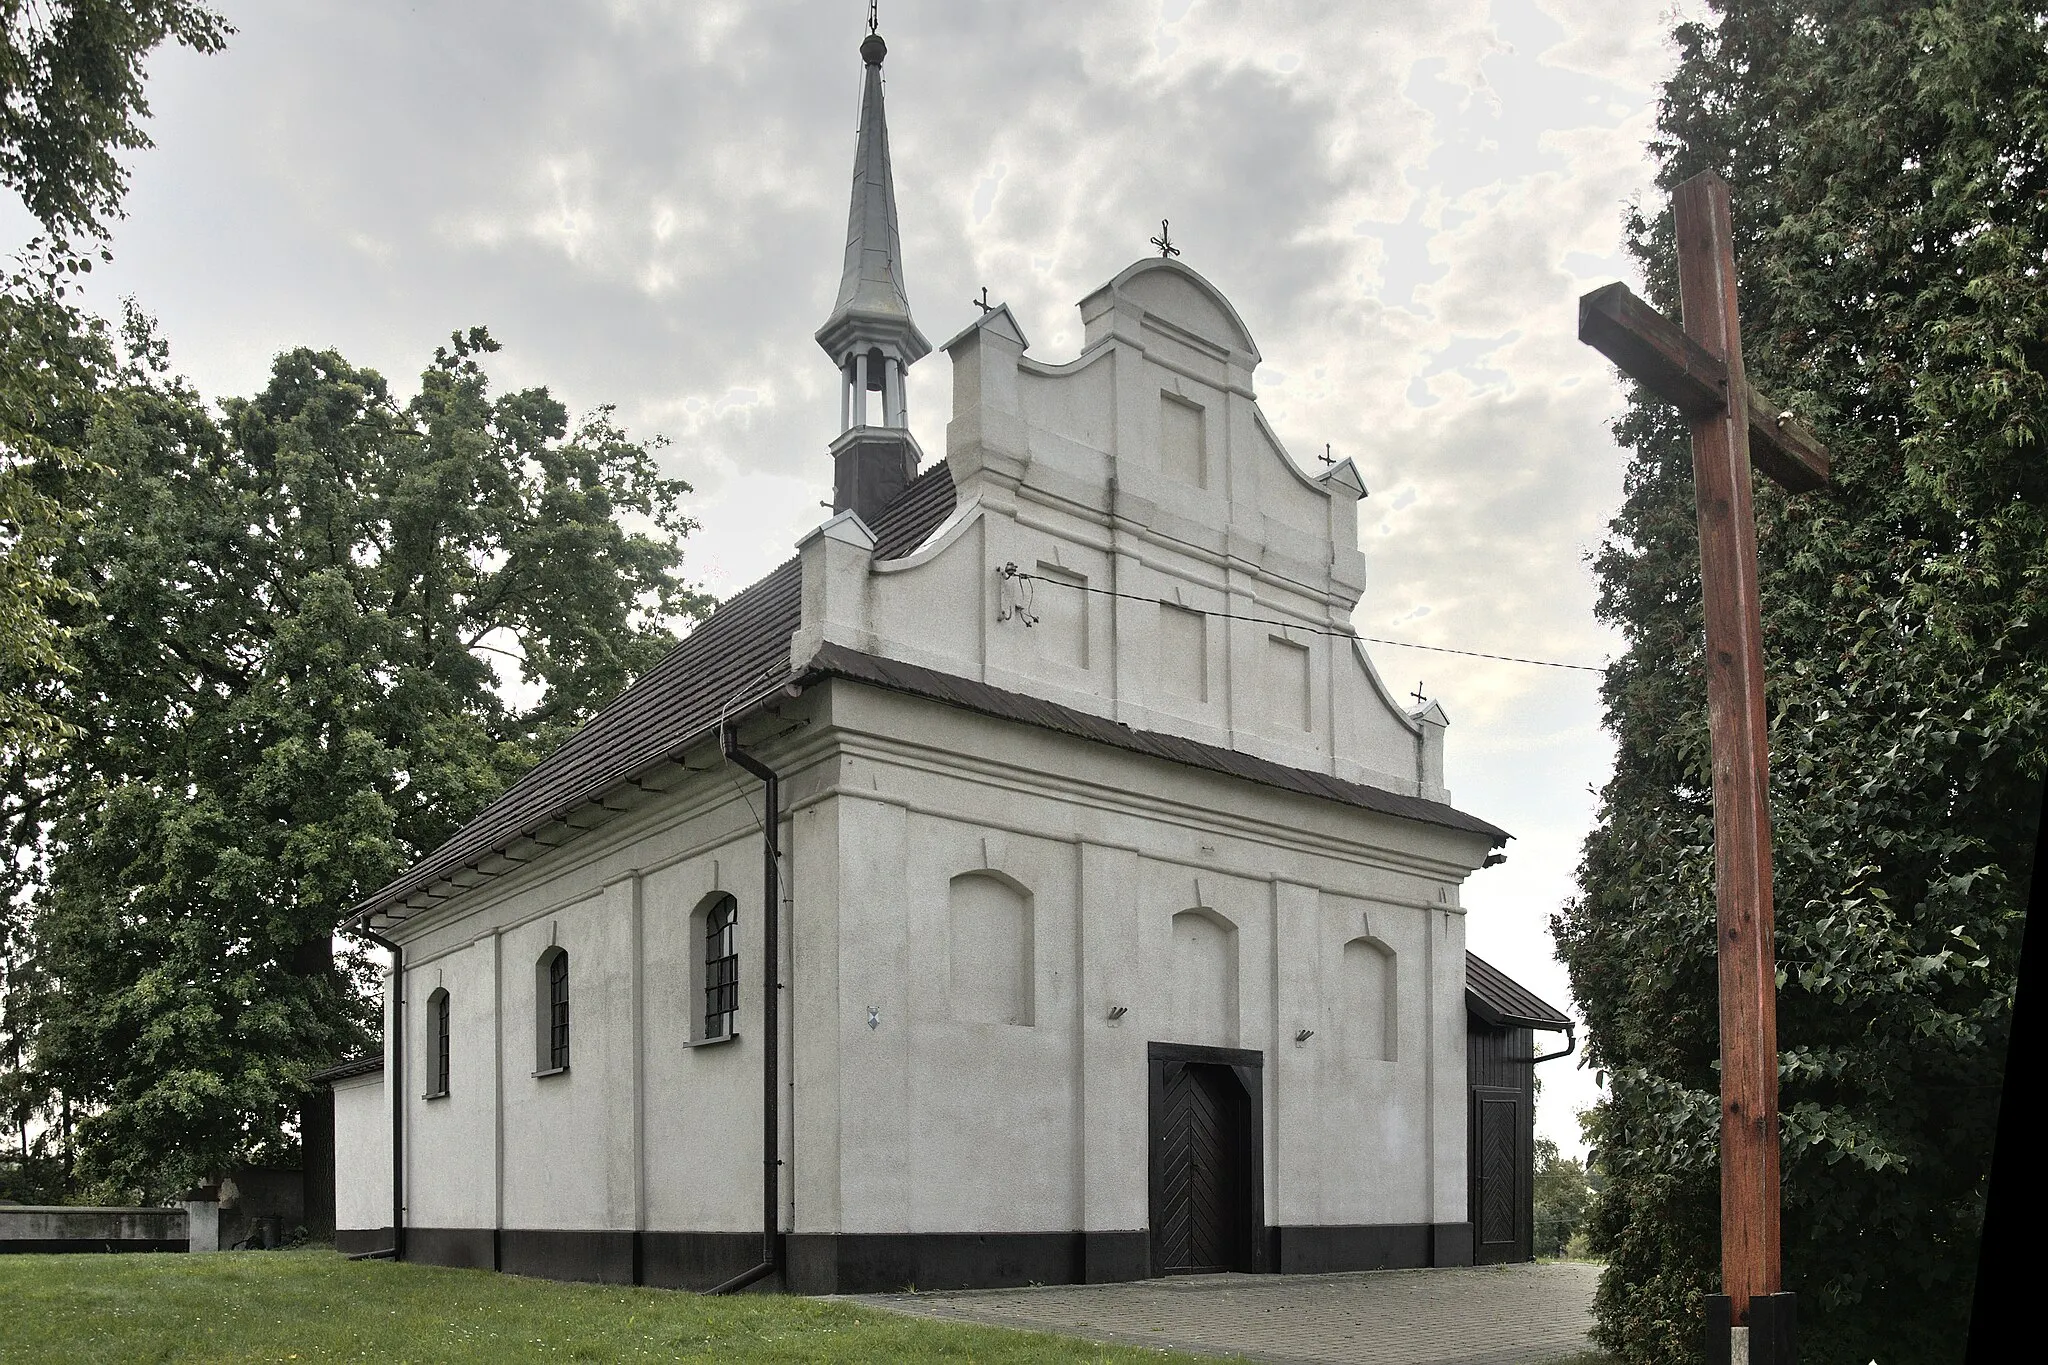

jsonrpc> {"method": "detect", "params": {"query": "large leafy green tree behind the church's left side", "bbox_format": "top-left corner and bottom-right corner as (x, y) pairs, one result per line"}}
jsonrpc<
(14, 325), (709, 1197)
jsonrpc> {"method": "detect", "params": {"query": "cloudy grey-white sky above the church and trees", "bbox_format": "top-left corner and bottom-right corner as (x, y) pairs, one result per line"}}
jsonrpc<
(0, 0), (1703, 1148)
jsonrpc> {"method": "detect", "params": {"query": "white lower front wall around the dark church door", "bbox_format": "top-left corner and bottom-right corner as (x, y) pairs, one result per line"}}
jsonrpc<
(797, 684), (1483, 1268)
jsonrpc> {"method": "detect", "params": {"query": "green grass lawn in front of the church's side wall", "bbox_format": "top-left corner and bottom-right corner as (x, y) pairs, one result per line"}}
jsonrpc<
(0, 1250), (1202, 1365)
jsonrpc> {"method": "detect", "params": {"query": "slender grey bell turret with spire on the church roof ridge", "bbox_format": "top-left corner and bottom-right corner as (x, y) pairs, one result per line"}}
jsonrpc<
(817, 15), (932, 524)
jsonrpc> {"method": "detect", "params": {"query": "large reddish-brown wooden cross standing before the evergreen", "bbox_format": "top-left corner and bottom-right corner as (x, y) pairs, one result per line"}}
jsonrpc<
(1579, 172), (1827, 1365)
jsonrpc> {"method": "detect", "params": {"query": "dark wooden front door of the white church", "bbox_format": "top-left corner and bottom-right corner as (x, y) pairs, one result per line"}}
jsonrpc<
(1151, 1044), (1264, 1275)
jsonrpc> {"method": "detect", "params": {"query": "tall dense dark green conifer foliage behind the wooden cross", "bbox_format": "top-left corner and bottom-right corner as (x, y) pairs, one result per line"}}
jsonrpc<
(1554, 0), (2048, 1365)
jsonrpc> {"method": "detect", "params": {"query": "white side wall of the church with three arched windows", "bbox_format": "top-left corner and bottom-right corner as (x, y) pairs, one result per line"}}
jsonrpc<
(377, 774), (786, 1232)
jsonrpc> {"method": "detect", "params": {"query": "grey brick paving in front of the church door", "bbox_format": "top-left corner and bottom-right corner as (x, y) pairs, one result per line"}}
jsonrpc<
(858, 1265), (1599, 1365)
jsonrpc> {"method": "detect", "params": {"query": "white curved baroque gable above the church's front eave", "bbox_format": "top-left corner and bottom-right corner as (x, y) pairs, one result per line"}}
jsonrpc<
(793, 260), (1450, 800)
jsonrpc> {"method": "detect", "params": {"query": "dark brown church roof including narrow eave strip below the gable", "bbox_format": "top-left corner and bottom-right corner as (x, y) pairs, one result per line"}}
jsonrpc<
(352, 460), (1507, 923)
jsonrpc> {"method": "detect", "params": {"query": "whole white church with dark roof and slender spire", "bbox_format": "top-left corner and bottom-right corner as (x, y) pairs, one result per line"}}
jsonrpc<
(330, 33), (1567, 1293)
